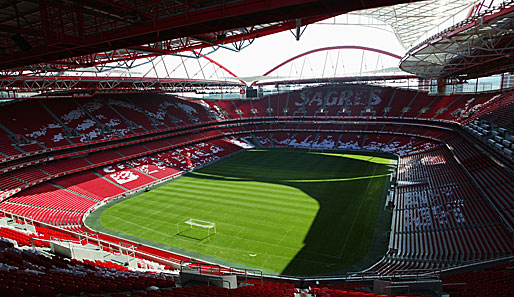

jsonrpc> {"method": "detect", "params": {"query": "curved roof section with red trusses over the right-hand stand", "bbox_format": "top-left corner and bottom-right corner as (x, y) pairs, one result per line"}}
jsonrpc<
(400, 1), (514, 79)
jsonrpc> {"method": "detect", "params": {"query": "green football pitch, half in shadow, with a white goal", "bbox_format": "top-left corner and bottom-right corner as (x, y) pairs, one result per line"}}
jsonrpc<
(86, 149), (396, 275)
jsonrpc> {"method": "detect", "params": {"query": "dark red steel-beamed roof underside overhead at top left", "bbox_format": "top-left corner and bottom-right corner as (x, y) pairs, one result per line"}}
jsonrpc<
(0, 0), (416, 71)
